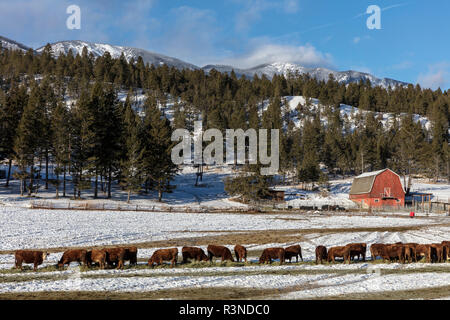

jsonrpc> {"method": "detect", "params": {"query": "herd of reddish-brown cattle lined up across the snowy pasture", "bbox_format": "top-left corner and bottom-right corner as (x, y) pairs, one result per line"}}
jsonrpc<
(11, 241), (450, 271)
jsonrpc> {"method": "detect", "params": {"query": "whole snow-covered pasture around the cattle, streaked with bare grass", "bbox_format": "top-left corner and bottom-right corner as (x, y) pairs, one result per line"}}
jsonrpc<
(0, 201), (450, 299)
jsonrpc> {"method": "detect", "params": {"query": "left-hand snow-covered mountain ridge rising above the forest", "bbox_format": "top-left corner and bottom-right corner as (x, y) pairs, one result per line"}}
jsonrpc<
(36, 40), (199, 69)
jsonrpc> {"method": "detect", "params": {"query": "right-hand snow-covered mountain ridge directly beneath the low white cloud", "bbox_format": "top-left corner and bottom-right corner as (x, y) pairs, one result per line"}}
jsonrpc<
(202, 62), (408, 88)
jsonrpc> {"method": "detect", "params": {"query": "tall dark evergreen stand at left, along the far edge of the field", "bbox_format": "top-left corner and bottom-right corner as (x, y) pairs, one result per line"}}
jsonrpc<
(0, 77), (177, 201)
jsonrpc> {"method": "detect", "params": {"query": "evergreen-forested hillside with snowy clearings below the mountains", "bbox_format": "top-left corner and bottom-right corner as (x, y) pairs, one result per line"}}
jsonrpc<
(0, 45), (450, 199)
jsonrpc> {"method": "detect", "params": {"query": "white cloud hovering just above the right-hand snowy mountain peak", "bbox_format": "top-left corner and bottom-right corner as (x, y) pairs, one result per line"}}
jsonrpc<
(214, 43), (333, 68)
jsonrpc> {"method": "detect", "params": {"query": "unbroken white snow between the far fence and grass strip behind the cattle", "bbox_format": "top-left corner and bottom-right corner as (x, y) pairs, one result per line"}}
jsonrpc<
(0, 207), (441, 250)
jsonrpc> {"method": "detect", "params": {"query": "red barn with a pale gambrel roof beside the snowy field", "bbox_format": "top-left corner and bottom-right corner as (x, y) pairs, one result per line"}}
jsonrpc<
(350, 169), (405, 208)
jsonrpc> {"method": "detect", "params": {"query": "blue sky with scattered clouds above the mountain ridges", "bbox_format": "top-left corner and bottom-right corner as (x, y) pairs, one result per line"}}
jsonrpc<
(0, 0), (450, 89)
